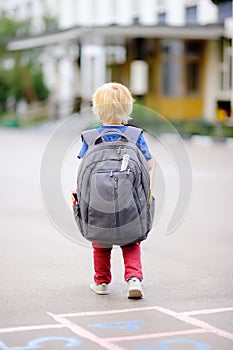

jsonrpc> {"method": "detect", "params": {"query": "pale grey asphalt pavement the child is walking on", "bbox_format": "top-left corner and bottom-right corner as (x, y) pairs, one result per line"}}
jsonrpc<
(0, 119), (233, 350)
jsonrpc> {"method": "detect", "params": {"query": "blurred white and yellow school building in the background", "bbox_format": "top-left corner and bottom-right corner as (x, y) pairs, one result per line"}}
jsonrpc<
(1, 0), (233, 121)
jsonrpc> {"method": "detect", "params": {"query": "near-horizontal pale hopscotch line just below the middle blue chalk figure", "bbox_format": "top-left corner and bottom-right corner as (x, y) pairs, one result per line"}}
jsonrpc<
(104, 328), (209, 342)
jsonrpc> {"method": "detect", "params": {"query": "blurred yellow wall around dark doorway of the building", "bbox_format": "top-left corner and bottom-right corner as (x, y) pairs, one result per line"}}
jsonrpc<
(111, 39), (208, 120)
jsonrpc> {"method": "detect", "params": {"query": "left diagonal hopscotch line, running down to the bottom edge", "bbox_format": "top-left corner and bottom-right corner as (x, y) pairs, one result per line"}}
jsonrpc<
(47, 312), (126, 350)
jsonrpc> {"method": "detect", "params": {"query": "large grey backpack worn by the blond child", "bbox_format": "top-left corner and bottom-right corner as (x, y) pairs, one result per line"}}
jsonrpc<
(73, 126), (155, 246)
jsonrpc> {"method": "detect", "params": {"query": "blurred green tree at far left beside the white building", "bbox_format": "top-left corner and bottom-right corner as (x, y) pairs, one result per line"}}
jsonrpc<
(0, 17), (49, 112)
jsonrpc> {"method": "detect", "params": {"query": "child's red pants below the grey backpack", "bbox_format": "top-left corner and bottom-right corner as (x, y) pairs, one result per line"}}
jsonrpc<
(92, 242), (143, 284)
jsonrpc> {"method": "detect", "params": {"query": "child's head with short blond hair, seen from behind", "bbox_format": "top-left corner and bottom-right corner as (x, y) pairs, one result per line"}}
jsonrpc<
(93, 83), (134, 124)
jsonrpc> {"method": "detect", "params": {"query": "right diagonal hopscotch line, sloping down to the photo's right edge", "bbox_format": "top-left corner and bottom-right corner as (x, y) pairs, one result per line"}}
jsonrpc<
(156, 306), (233, 341)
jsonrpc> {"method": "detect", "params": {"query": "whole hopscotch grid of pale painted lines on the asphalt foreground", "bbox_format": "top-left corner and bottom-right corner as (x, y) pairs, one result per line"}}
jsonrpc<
(0, 306), (233, 350)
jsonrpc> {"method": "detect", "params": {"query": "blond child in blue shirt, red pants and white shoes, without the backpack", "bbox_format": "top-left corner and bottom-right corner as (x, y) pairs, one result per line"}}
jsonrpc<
(78, 83), (152, 299)
